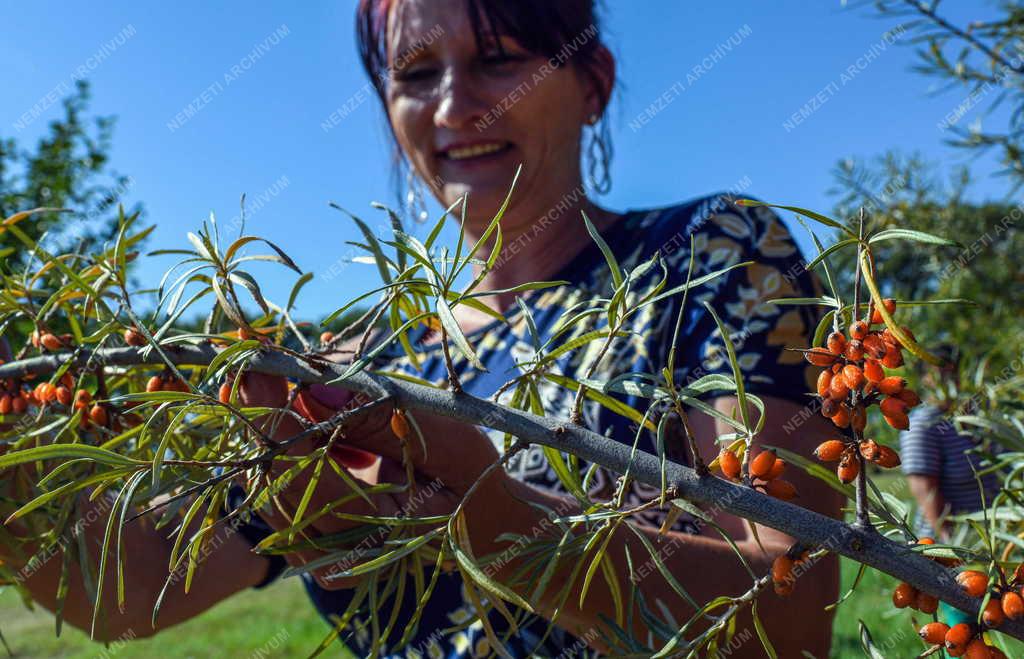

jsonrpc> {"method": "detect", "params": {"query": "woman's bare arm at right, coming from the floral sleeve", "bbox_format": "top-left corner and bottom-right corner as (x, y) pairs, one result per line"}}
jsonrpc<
(467, 397), (841, 657)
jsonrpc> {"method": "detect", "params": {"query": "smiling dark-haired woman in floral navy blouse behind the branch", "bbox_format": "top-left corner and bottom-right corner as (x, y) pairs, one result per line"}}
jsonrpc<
(0, 0), (839, 657)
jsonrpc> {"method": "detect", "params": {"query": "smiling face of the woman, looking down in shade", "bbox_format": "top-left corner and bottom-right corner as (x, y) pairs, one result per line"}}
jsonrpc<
(387, 0), (600, 230)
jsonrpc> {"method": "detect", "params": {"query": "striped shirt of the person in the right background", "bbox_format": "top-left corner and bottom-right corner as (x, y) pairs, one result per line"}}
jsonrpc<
(899, 405), (998, 536)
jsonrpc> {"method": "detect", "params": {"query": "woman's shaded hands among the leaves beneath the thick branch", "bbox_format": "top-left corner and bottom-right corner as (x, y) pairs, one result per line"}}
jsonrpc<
(234, 374), (512, 589)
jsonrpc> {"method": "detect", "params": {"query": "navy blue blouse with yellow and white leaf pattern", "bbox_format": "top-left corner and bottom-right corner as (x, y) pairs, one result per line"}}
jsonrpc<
(235, 194), (821, 658)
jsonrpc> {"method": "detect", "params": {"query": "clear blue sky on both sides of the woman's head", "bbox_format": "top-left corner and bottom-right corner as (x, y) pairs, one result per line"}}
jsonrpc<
(0, 0), (1005, 317)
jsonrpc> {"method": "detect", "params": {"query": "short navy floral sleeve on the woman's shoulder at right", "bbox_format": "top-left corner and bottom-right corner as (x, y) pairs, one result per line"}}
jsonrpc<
(664, 196), (823, 405)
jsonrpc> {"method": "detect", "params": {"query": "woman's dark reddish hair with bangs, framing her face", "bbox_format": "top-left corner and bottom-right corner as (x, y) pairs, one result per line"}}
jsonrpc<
(355, 0), (611, 210)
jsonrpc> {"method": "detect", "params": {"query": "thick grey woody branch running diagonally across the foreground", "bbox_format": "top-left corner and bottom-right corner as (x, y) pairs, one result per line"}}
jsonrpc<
(0, 345), (1024, 640)
